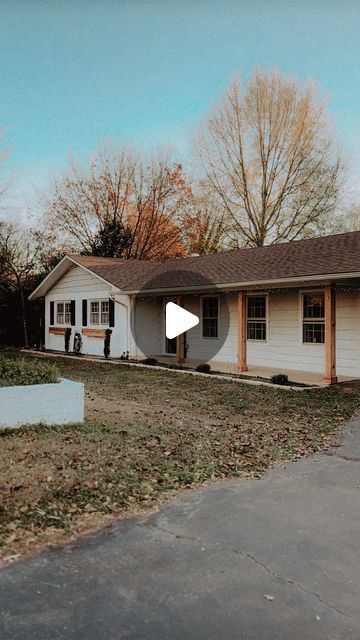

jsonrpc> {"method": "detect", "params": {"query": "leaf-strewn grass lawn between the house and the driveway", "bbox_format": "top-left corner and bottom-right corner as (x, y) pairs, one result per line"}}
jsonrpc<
(0, 358), (360, 560)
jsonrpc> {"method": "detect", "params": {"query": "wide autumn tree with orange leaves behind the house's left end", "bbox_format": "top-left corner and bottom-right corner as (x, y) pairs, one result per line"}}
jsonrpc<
(46, 144), (191, 259)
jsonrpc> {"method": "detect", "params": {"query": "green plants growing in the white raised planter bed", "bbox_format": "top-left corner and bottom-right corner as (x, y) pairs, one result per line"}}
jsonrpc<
(0, 357), (59, 387)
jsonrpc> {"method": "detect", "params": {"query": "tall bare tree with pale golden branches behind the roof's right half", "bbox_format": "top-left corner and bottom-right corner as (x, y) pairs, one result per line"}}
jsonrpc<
(195, 69), (341, 246)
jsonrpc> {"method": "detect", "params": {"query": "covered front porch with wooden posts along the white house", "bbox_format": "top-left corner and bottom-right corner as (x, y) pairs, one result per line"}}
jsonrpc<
(148, 283), (360, 386)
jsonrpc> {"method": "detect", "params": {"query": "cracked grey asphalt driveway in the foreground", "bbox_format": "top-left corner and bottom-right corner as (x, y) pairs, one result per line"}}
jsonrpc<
(0, 421), (360, 640)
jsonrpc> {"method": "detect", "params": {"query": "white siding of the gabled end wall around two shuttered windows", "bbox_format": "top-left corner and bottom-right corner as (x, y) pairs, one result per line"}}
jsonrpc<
(45, 267), (129, 357)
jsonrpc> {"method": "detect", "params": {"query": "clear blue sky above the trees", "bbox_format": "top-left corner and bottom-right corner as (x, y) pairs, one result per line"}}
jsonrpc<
(0, 0), (360, 220)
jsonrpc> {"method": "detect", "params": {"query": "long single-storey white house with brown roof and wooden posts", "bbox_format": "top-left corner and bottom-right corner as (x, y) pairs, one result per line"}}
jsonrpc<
(30, 232), (360, 383)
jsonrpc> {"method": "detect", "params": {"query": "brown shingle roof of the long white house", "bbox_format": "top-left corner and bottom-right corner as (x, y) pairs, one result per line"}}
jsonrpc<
(71, 231), (360, 291)
